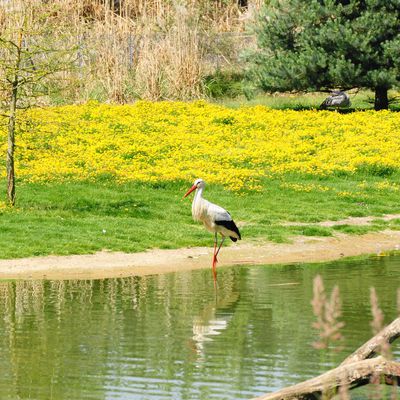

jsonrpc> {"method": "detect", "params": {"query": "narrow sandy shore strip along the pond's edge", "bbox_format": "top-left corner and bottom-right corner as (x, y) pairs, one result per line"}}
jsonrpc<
(0, 231), (400, 279)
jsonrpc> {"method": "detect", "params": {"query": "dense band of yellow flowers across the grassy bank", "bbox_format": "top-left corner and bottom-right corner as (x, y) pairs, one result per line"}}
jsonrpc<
(0, 101), (400, 190)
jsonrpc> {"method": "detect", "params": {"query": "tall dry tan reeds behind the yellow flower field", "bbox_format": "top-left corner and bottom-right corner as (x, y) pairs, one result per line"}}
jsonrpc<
(0, 0), (261, 103)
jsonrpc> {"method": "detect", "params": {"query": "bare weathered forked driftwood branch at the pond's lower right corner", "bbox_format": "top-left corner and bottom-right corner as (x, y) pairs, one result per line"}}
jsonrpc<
(254, 318), (400, 400)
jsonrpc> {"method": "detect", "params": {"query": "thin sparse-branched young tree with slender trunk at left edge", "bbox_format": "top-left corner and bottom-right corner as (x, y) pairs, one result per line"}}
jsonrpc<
(0, 0), (73, 206)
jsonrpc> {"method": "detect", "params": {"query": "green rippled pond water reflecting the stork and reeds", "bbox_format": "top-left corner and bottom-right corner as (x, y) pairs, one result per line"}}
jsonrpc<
(0, 256), (400, 400)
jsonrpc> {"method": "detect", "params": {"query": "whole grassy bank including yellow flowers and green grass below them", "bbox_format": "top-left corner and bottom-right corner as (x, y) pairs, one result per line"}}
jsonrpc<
(0, 101), (400, 258)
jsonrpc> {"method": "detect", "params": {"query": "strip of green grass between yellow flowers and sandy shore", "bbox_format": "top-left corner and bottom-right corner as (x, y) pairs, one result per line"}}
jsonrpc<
(0, 174), (400, 259)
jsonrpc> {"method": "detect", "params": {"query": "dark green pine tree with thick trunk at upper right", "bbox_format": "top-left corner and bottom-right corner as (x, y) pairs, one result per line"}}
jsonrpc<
(247, 0), (400, 110)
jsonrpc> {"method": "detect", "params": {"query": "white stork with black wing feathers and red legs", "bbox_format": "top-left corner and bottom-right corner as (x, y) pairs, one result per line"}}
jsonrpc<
(183, 179), (241, 287)
